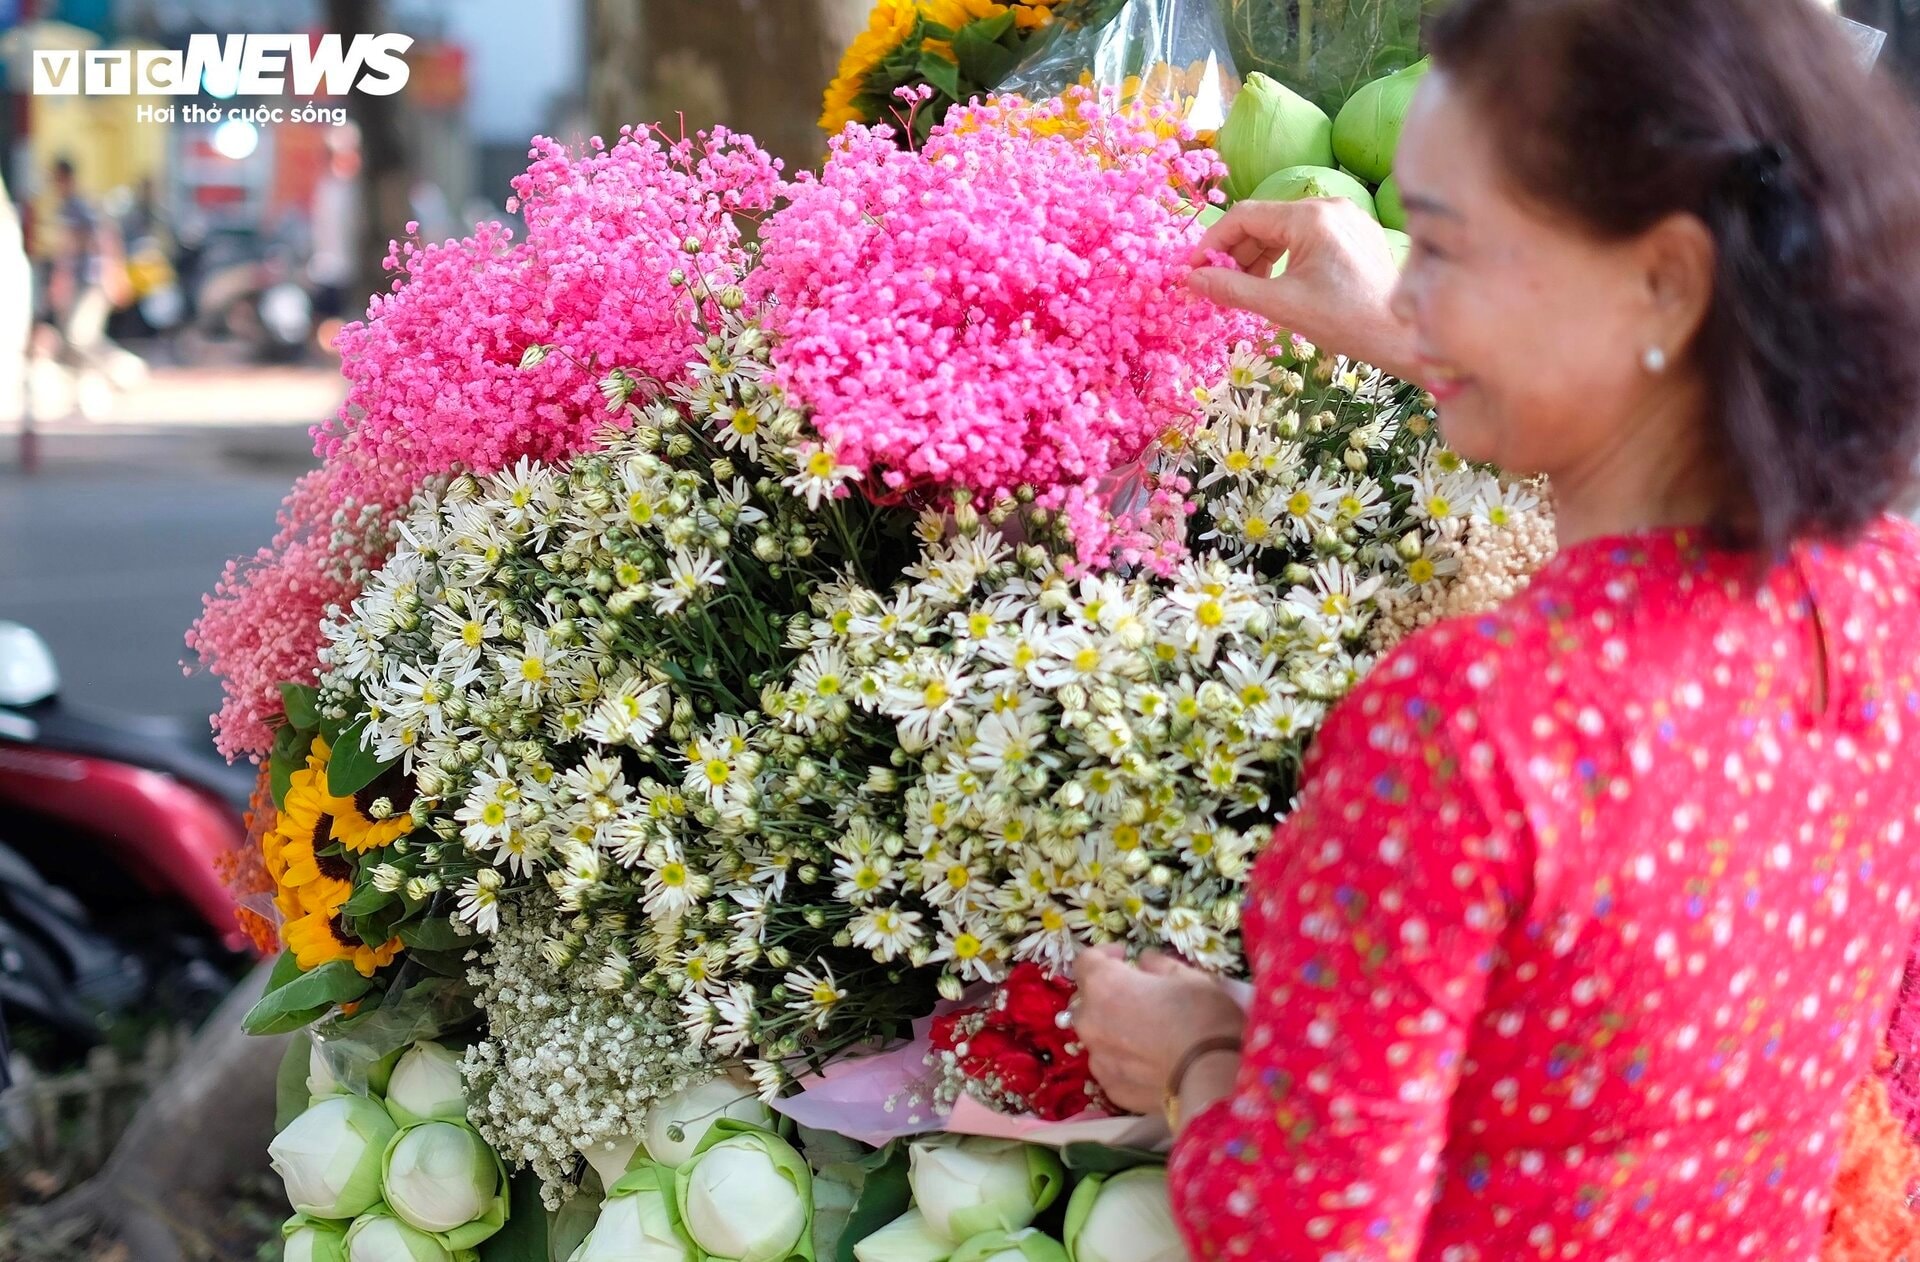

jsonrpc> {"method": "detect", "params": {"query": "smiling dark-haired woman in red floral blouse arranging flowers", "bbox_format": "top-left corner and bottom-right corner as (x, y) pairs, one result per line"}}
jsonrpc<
(1075, 0), (1920, 1262)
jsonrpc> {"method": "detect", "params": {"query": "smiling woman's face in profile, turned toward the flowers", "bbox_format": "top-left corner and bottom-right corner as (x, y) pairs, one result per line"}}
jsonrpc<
(1394, 71), (1680, 474)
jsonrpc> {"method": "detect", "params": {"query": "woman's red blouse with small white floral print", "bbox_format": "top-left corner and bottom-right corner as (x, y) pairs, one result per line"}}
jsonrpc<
(1171, 519), (1920, 1262)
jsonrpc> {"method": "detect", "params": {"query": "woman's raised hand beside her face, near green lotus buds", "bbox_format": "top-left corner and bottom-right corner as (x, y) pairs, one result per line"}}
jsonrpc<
(1188, 198), (1415, 376)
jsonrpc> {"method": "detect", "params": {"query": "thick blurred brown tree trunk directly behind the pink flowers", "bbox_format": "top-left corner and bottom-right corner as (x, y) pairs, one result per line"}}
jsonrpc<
(588, 0), (872, 169)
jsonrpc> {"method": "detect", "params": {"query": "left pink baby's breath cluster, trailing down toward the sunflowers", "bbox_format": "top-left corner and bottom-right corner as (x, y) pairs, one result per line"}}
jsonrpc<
(188, 129), (781, 757)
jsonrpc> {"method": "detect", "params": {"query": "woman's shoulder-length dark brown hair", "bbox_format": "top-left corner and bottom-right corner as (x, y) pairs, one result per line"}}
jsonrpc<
(1430, 0), (1920, 549)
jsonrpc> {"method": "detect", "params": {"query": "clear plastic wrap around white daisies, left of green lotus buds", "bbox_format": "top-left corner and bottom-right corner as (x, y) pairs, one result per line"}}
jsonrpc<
(1000, 0), (1240, 140)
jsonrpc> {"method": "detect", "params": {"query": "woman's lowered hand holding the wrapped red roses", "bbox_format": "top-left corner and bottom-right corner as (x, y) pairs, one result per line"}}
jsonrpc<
(1073, 947), (1246, 1114)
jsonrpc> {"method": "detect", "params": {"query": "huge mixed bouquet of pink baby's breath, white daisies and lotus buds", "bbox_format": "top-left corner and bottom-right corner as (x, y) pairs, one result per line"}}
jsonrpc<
(196, 83), (1551, 1262)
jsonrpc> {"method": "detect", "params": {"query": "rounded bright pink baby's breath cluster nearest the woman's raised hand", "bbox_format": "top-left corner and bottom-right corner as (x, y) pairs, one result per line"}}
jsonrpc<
(756, 90), (1246, 567)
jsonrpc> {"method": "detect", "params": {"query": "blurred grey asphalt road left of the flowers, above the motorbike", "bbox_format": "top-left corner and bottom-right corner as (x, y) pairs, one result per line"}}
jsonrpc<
(0, 430), (305, 722)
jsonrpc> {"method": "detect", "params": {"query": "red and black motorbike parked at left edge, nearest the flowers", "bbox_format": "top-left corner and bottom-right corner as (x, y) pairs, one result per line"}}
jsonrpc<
(0, 622), (253, 1060)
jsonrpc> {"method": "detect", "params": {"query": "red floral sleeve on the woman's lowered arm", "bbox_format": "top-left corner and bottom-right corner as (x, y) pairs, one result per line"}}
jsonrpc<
(1173, 642), (1526, 1260)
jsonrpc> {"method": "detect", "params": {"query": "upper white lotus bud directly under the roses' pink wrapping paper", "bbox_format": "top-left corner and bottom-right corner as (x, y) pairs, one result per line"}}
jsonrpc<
(906, 1135), (1066, 1245)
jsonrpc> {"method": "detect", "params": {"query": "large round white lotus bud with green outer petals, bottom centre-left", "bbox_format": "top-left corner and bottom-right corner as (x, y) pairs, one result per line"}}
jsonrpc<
(674, 1122), (814, 1262)
